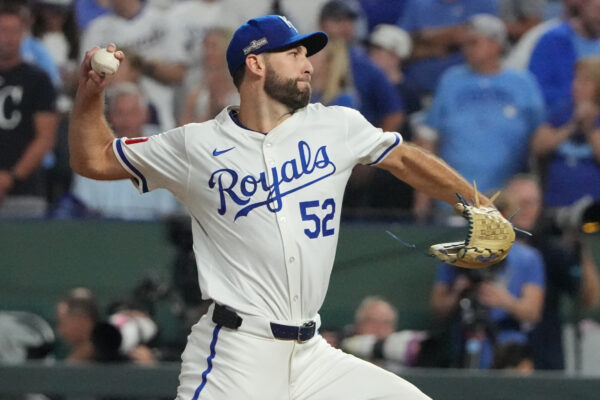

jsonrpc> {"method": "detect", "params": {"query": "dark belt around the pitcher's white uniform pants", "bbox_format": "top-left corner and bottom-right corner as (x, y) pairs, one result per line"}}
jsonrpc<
(212, 304), (317, 343)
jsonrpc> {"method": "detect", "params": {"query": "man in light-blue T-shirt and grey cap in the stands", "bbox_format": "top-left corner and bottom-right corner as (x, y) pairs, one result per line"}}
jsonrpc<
(415, 14), (544, 222)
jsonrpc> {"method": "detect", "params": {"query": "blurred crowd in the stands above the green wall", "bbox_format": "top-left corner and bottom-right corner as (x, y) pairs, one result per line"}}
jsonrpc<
(0, 0), (600, 223)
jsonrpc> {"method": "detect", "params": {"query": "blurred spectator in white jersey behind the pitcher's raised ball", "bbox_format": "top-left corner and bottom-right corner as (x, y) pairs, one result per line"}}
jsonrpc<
(79, 0), (187, 130)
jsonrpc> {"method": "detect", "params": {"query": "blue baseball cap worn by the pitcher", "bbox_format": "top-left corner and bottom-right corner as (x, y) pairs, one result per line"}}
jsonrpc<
(227, 15), (328, 75)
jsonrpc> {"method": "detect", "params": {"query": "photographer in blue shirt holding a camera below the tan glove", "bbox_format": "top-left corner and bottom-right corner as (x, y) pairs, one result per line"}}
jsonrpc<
(431, 198), (545, 368)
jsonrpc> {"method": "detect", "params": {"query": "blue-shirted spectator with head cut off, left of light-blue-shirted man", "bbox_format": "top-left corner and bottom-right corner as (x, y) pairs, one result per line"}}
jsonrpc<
(398, 0), (498, 95)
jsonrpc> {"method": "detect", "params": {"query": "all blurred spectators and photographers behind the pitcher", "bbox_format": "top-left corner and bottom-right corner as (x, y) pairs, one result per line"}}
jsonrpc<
(0, 0), (600, 380)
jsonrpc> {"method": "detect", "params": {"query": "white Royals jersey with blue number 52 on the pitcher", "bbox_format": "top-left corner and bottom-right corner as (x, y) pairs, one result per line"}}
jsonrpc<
(113, 104), (402, 324)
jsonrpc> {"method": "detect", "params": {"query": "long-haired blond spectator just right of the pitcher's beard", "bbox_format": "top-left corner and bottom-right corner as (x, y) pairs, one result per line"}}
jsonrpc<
(311, 39), (359, 108)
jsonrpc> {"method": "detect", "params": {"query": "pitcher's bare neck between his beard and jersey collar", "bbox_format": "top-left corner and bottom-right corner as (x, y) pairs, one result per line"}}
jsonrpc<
(238, 87), (292, 133)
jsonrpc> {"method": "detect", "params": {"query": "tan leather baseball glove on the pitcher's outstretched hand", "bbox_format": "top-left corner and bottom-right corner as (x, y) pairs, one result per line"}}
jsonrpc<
(429, 188), (515, 268)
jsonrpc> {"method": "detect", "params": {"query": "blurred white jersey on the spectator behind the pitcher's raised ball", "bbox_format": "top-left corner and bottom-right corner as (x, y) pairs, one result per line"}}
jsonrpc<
(80, 5), (186, 129)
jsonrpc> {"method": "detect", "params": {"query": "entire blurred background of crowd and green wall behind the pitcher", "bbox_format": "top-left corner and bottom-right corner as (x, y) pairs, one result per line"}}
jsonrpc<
(0, 0), (600, 399)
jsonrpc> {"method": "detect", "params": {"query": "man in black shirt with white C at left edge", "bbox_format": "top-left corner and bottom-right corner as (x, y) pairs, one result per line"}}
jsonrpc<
(0, 5), (57, 217)
